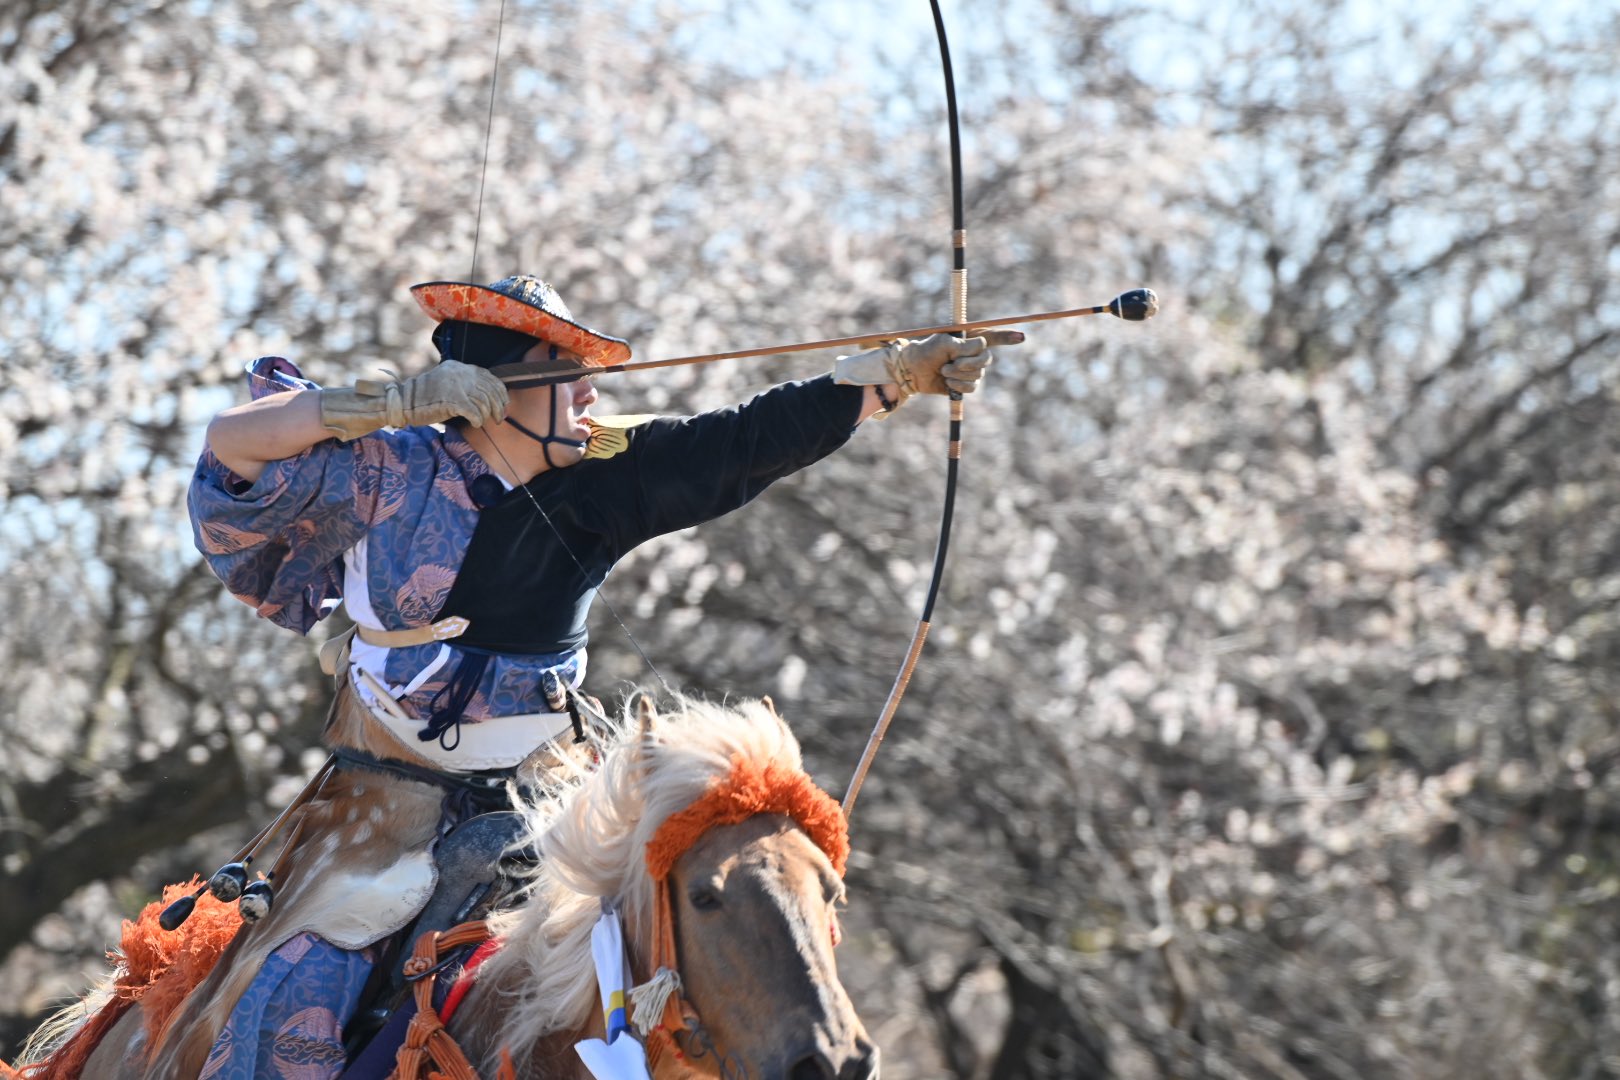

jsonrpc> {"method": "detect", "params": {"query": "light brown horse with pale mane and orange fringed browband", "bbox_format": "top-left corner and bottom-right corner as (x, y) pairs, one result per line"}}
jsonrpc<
(9, 696), (880, 1080)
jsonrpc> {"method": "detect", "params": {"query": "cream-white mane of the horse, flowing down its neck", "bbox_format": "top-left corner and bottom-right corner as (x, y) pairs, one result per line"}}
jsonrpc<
(480, 698), (804, 1057)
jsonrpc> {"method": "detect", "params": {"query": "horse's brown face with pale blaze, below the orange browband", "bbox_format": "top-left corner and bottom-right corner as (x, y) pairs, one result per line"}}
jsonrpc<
(669, 814), (878, 1080)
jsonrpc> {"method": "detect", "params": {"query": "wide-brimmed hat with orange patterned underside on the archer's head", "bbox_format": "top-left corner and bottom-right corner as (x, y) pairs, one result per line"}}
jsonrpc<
(410, 274), (630, 368)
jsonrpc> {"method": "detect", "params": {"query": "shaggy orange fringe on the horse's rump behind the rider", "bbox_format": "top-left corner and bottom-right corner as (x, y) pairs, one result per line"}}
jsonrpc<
(0, 878), (241, 1080)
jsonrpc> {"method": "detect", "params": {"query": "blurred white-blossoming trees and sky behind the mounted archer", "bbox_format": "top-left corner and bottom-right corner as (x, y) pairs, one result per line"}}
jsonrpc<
(0, 0), (1620, 1080)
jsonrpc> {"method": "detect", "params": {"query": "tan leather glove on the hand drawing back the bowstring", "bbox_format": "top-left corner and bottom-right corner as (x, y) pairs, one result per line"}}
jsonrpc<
(321, 359), (507, 442)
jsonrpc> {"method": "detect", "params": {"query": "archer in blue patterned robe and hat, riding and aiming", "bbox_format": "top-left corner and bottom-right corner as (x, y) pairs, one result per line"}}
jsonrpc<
(167, 277), (1022, 1080)
